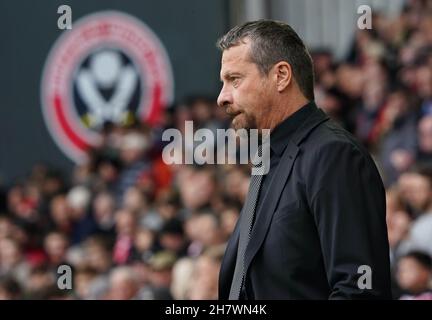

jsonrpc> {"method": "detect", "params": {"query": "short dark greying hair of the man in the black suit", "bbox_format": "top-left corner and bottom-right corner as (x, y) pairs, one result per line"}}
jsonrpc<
(217, 20), (314, 100)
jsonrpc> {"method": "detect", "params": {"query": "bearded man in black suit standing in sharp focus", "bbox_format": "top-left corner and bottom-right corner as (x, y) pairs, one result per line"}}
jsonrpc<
(218, 20), (391, 299)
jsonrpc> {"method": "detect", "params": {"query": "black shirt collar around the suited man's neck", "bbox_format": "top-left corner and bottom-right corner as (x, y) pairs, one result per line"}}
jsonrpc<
(270, 101), (317, 156)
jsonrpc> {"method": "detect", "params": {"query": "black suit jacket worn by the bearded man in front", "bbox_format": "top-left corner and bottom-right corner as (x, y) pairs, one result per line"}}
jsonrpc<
(219, 105), (391, 299)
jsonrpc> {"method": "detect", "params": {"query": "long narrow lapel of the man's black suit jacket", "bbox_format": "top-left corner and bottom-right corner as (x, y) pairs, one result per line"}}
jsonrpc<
(245, 109), (329, 274)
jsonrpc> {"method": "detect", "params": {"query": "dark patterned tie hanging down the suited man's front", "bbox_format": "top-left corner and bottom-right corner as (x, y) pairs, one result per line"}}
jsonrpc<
(229, 146), (264, 300)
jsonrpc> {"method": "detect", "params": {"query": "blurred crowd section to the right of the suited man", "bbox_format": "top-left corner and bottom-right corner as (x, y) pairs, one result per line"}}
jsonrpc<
(313, 0), (432, 299)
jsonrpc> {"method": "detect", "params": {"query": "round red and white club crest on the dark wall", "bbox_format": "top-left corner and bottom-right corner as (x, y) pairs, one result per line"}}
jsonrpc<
(41, 11), (173, 162)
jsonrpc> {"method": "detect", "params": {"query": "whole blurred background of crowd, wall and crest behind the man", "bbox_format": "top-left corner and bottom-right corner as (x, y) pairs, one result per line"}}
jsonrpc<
(0, 0), (432, 299)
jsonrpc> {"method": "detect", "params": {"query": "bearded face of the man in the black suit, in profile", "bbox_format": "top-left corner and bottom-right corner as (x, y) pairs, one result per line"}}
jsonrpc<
(218, 40), (272, 130)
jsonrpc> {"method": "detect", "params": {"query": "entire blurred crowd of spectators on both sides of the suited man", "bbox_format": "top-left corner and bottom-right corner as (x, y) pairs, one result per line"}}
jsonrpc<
(0, 0), (432, 299)
